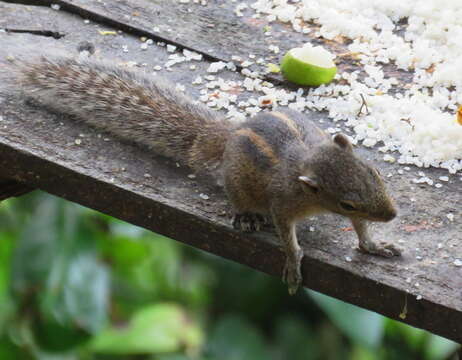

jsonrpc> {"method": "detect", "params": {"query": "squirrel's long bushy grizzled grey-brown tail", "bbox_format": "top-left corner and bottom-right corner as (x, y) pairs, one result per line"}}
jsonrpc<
(13, 57), (230, 170)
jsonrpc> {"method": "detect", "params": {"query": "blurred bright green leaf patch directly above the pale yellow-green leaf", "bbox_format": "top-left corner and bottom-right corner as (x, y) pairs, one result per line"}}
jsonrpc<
(98, 229), (214, 318)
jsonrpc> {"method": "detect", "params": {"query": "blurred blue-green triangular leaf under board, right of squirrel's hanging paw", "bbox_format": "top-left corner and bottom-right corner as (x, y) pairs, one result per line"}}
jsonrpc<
(307, 290), (384, 348)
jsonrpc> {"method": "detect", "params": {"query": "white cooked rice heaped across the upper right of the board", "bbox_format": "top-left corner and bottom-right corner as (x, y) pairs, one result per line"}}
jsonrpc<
(240, 0), (462, 173)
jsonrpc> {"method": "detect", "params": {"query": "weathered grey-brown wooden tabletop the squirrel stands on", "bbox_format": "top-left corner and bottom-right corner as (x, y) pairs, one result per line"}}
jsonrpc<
(0, 0), (462, 342)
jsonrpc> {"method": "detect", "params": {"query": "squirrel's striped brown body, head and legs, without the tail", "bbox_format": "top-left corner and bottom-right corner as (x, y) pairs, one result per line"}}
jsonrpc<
(223, 110), (400, 293)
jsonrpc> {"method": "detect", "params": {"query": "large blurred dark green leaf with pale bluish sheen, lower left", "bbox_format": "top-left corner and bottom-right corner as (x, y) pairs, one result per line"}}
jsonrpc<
(13, 196), (109, 352)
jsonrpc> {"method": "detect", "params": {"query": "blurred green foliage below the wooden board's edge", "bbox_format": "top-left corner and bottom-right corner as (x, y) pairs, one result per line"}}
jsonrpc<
(0, 192), (457, 360)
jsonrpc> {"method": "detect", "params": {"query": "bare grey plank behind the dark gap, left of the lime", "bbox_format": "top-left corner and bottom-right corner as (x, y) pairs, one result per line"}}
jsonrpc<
(30, 0), (267, 61)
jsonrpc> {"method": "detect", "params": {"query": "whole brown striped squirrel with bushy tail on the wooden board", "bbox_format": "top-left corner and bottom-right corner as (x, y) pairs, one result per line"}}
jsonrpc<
(9, 57), (401, 294)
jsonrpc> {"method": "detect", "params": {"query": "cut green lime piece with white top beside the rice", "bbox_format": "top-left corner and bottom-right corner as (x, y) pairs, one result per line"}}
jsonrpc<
(281, 44), (337, 86)
